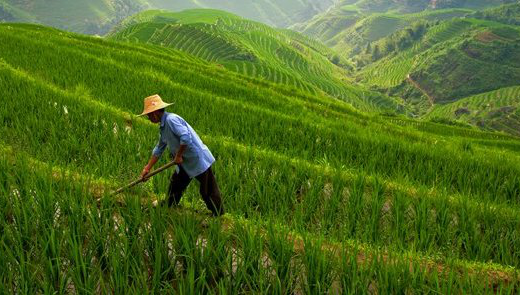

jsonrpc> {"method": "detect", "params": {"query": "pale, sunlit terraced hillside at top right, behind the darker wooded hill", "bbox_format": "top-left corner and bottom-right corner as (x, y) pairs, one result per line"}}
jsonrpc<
(291, 0), (518, 56)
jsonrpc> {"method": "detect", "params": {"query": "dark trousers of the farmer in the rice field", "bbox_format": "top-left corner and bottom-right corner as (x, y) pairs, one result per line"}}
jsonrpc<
(168, 165), (224, 216)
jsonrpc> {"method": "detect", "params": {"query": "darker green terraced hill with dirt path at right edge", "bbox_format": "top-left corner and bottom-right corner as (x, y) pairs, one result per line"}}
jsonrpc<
(358, 18), (520, 135)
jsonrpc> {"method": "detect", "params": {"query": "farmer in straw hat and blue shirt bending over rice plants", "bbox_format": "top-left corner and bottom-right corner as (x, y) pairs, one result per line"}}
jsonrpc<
(141, 95), (224, 216)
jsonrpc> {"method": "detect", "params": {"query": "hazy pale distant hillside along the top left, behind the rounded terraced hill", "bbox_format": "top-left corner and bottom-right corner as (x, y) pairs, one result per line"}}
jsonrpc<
(0, 0), (333, 35)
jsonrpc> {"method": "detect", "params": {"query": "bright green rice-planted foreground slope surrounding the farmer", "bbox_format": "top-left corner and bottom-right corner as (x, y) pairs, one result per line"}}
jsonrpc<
(0, 25), (520, 293)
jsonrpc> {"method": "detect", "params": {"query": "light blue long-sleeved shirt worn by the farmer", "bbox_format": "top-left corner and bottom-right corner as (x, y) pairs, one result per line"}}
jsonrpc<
(152, 112), (215, 178)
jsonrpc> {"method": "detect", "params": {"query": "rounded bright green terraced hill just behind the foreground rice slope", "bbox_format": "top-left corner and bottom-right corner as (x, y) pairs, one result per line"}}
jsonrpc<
(109, 9), (398, 110)
